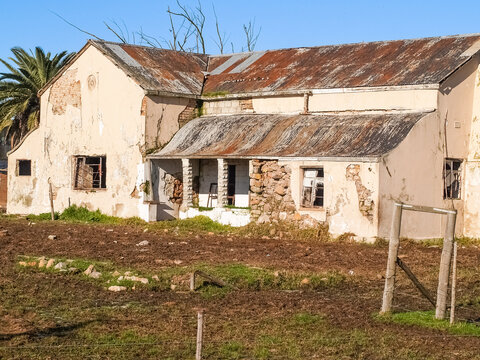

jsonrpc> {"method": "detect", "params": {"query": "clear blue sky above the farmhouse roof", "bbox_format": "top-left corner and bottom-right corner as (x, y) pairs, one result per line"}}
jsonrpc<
(0, 0), (480, 70)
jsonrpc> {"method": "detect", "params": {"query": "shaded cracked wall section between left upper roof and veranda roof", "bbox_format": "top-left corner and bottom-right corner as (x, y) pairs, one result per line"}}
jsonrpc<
(142, 96), (195, 150)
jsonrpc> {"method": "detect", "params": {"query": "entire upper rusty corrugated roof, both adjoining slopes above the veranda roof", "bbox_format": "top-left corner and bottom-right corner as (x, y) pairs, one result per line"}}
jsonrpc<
(90, 35), (480, 96)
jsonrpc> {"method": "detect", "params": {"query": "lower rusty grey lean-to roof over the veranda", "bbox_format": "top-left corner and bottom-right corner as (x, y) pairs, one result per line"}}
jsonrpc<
(150, 112), (426, 158)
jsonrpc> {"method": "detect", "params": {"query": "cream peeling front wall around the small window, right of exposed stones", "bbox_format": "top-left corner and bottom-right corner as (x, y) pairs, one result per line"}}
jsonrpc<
(279, 160), (379, 240)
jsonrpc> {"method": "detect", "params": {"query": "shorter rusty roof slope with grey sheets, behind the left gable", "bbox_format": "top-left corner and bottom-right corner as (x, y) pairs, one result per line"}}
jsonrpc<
(90, 40), (207, 95)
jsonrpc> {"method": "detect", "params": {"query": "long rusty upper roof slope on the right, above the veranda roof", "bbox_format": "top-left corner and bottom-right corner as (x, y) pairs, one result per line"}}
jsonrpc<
(204, 34), (480, 94)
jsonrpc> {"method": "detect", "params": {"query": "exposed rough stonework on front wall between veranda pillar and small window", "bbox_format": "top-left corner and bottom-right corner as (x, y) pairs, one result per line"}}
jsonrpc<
(250, 160), (316, 226)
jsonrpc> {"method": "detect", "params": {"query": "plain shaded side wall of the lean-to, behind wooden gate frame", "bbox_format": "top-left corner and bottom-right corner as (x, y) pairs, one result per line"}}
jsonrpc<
(379, 112), (445, 239)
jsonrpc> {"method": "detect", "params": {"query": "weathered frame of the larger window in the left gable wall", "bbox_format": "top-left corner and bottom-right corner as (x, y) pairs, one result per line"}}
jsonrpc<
(72, 155), (107, 191)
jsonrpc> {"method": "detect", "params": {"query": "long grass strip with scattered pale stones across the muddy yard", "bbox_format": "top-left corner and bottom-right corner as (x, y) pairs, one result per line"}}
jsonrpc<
(18, 256), (346, 298)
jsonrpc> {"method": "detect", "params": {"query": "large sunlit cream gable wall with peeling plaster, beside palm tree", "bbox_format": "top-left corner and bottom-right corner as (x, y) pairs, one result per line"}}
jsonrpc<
(7, 47), (149, 220)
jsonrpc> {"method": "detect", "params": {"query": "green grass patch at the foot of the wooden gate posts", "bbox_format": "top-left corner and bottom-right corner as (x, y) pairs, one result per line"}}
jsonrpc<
(376, 311), (480, 336)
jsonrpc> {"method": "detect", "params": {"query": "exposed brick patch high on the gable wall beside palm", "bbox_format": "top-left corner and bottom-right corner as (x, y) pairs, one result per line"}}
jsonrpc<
(48, 69), (82, 115)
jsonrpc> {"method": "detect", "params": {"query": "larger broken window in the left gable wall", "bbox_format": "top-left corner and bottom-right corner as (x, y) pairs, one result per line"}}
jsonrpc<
(73, 156), (107, 190)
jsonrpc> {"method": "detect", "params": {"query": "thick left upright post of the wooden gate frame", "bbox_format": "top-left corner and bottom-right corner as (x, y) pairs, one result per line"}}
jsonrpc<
(380, 203), (402, 314)
